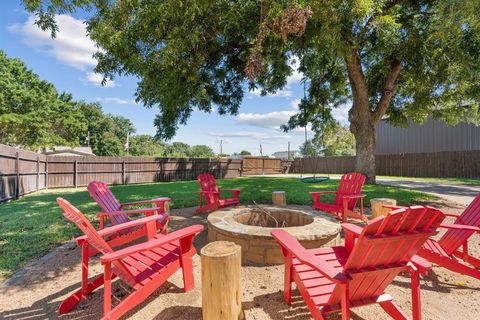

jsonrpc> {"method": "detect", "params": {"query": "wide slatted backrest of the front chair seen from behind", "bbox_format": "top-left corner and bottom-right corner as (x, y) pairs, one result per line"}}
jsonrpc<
(329, 206), (445, 303)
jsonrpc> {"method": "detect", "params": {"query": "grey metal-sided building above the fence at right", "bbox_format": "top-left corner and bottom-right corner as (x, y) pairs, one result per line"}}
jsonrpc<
(376, 119), (480, 154)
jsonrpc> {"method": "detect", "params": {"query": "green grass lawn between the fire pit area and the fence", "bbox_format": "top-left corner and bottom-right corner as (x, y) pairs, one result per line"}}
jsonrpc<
(0, 177), (434, 276)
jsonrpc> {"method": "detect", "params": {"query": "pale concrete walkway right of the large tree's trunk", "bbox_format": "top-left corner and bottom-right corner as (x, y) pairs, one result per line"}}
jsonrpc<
(377, 178), (480, 207)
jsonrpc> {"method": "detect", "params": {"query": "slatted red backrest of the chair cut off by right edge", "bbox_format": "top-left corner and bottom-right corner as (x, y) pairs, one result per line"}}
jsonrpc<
(438, 193), (480, 255)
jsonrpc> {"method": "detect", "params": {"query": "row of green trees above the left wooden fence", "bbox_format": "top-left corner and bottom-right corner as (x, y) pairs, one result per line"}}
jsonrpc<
(0, 51), (215, 158)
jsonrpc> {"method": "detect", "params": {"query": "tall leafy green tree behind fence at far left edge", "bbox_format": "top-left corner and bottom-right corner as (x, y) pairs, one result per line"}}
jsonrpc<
(0, 50), (86, 150)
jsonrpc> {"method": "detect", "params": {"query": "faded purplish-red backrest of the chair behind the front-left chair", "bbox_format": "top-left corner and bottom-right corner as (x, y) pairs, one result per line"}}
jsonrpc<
(87, 181), (130, 225)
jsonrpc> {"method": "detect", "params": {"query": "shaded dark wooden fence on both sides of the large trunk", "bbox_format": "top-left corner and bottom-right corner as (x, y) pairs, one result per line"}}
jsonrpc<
(290, 150), (480, 179)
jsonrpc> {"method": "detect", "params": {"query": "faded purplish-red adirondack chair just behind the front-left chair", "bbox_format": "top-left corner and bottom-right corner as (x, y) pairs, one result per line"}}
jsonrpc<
(87, 181), (170, 247)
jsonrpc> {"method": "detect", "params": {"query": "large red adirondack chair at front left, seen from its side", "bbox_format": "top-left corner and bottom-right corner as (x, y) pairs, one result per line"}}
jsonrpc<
(57, 198), (203, 319)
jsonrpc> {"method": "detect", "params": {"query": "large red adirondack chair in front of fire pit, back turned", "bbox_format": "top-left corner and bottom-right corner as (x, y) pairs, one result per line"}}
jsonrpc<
(271, 206), (445, 320)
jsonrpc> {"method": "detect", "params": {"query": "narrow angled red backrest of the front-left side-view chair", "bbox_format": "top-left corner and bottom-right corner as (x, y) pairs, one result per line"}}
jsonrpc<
(57, 198), (136, 285)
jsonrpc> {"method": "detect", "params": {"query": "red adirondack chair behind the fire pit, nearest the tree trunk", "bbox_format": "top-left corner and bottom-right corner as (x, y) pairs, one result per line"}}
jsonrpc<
(310, 172), (367, 222)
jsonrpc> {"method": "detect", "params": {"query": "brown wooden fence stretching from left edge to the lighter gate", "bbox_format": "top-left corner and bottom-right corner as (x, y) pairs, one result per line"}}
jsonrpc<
(0, 144), (242, 202)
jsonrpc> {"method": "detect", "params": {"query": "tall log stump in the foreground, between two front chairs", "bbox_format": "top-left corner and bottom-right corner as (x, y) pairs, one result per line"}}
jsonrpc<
(201, 241), (244, 320)
